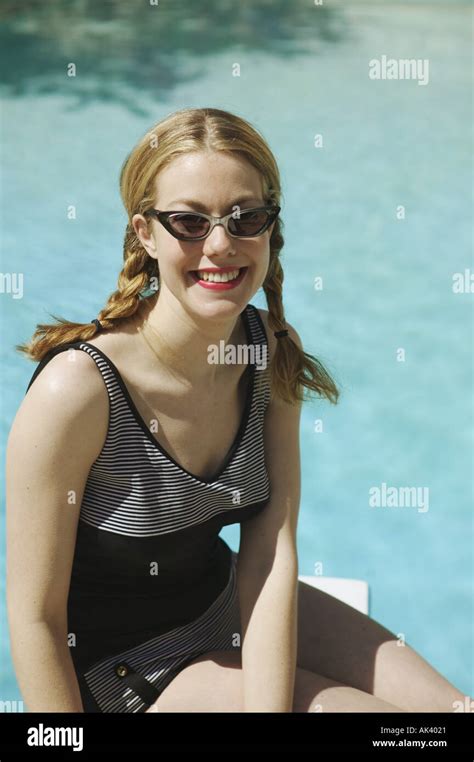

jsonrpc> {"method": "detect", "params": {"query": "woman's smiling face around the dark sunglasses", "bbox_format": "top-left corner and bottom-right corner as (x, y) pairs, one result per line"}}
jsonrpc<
(133, 152), (273, 318)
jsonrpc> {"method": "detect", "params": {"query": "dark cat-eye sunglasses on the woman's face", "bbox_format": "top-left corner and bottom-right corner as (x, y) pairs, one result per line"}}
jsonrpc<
(143, 204), (280, 241)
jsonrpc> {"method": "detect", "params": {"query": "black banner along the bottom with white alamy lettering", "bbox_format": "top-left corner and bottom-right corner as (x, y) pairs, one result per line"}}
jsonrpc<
(0, 712), (473, 762)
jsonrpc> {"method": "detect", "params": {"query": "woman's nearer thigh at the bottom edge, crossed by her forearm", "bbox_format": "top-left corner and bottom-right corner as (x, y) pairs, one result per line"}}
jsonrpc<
(147, 651), (403, 712)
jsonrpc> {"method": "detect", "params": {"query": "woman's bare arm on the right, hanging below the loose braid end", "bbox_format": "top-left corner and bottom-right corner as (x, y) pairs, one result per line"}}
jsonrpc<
(237, 312), (301, 712)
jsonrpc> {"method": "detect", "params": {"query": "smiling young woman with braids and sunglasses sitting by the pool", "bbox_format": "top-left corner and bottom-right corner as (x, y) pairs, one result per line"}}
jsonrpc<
(7, 108), (463, 712)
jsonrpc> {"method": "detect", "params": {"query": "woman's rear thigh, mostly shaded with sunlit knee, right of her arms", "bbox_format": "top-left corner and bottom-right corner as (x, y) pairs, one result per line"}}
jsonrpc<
(297, 580), (463, 712)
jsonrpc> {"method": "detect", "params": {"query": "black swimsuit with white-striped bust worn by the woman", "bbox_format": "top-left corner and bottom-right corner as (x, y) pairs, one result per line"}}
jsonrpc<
(28, 304), (270, 712)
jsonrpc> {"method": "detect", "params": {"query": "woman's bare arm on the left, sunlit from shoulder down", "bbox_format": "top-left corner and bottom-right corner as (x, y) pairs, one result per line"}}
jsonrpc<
(6, 350), (109, 712)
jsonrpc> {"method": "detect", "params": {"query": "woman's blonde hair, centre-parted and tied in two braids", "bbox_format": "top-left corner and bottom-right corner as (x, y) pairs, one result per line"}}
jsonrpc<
(16, 108), (339, 404)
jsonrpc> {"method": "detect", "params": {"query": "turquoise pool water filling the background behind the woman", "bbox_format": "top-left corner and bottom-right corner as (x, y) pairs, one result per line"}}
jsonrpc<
(0, 2), (474, 700)
